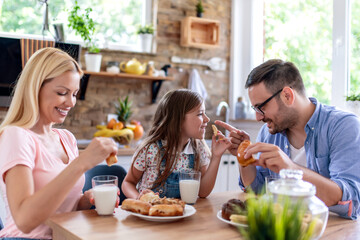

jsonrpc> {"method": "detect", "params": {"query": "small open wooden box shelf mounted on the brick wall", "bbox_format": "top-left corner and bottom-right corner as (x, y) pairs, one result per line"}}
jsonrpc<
(180, 17), (220, 48)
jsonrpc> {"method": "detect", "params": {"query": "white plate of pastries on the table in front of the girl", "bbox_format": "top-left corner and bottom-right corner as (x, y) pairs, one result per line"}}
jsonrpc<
(121, 192), (196, 222)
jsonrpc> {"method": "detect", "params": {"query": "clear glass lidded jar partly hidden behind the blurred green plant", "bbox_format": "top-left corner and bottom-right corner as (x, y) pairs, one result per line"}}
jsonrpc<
(268, 169), (329, 239)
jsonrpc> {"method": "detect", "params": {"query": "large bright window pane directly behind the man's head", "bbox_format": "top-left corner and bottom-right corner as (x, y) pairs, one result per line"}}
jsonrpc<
(264, 0), (334, 104)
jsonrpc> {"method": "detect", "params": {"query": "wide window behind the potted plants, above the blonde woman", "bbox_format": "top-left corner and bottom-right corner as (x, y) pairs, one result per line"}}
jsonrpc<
(0, 0), (152, 51)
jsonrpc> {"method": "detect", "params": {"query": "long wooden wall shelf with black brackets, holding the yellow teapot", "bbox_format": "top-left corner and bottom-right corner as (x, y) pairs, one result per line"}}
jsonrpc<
(79, 71), (174, 103)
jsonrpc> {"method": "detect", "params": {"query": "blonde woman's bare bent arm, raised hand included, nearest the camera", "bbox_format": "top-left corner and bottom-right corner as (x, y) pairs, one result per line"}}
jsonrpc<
(4, 138), (117, 233)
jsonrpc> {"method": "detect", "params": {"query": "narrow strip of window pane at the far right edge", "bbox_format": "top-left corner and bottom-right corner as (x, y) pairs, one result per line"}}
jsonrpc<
(348, 0), (360, 94)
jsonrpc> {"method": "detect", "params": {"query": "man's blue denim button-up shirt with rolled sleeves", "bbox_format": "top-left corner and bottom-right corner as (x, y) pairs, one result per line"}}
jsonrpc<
(239, 98), (360, 219)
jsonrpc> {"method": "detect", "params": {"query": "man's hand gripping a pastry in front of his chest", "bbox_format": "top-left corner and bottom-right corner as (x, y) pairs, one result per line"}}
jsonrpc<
(245, 142), (299, 173)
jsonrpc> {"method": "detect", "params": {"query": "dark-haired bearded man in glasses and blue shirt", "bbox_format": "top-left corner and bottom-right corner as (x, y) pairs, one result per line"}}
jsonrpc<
(215, 59), (360, 219)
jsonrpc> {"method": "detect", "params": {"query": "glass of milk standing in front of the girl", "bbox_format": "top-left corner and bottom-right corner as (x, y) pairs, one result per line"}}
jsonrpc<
(179, 171), (201, 205)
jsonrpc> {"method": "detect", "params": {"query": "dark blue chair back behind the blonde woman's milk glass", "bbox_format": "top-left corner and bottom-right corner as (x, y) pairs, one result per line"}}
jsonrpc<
(83, 165), (126, 205)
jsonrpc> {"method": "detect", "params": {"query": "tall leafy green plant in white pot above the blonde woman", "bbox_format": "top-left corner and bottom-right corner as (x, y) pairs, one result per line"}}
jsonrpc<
(68, 1), (102, 72)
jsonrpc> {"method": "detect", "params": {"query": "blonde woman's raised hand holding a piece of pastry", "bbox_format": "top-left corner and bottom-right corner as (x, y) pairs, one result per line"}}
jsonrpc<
(79, 137), (118, 169)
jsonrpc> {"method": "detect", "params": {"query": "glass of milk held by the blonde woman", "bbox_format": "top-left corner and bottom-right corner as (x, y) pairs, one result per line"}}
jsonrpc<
(91, 175), (118, 215)
